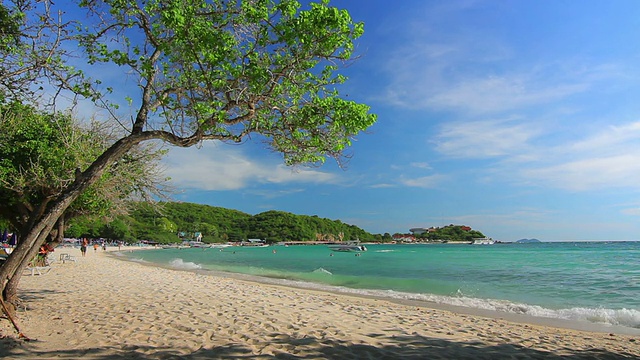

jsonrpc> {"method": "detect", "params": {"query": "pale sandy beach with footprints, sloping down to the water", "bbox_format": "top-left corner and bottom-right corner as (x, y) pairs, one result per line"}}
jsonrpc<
(0, 248), (640, 359)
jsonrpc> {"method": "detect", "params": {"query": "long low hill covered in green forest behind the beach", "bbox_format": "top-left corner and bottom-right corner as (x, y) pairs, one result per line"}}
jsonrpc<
(66, 202), (375, 243)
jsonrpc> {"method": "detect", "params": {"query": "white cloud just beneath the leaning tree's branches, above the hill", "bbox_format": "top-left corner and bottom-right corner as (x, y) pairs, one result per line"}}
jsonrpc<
(165, 143), (336, 190)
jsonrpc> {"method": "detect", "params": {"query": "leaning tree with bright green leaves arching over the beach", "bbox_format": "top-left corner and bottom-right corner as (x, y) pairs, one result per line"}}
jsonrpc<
(0, 0), (376, 318)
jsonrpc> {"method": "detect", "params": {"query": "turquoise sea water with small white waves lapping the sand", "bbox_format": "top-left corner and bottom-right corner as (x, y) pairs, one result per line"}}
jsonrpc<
(123, 242), (640, 328)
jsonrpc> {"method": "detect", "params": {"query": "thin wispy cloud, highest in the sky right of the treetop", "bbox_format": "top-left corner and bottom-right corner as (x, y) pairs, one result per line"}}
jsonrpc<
(382, 44), (606, 114)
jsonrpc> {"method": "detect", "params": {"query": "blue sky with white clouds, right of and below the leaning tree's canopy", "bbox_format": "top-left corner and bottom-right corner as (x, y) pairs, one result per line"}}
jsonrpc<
(158, 0), (640, 241)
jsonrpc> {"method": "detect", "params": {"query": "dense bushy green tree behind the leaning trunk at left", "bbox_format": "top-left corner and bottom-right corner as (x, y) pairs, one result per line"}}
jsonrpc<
(0, 102), (168, 310)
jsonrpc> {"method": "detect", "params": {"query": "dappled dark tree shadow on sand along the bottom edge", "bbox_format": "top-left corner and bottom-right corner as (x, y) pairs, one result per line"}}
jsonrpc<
(0, 334), (637, 360)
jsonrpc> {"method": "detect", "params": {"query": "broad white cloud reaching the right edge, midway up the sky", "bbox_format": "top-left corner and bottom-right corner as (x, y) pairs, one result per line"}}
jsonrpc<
(432, 110), (640, 191)
